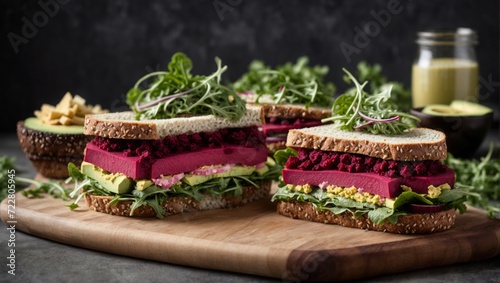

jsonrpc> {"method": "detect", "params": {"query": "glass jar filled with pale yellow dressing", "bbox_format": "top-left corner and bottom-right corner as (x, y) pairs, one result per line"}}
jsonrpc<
(412, 28), (479, 107)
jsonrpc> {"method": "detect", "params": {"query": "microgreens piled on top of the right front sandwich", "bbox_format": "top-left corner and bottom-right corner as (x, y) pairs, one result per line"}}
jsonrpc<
(322, 69), (419, 135)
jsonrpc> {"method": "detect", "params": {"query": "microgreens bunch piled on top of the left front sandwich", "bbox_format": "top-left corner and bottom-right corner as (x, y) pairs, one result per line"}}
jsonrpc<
(127, 52), (246, 121)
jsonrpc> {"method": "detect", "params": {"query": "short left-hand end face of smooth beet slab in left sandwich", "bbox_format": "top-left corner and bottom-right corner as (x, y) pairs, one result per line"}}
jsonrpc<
(83, 143), (151, 179)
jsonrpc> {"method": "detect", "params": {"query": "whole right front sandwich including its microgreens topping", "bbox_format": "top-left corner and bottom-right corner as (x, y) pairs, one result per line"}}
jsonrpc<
(272, 71), (468, 234)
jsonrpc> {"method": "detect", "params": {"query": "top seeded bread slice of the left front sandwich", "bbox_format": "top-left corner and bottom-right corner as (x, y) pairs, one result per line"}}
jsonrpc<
(84, 106), (264, 140)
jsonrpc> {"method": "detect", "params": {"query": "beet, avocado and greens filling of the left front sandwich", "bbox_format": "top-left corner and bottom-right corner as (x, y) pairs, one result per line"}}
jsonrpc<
(69, 126), (279, 218)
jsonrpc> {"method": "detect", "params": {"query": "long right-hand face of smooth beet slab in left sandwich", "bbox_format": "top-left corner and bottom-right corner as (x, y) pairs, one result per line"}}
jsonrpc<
(151, 145), (268, 178)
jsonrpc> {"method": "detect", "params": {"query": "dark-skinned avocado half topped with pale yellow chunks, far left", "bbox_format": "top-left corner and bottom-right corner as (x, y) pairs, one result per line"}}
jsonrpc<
(17, 92), (107, 179)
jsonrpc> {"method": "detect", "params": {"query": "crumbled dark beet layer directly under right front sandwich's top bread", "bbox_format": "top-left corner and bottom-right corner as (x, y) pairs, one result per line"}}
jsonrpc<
(286, 148), (446, 179)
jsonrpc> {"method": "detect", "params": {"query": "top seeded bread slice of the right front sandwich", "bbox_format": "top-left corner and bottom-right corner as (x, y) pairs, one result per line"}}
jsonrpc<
(286, 125), (447, 161)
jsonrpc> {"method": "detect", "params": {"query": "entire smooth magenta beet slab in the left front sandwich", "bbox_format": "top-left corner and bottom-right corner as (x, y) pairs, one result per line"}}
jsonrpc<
(84, 143), (267, 179)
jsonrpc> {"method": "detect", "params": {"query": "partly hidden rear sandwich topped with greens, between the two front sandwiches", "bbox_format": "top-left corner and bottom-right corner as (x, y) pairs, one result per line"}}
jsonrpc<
(232, 57), (335, 155)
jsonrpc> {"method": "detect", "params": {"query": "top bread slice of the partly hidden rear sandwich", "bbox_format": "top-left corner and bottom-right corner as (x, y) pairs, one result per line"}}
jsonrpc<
(257, 104), (332, 120)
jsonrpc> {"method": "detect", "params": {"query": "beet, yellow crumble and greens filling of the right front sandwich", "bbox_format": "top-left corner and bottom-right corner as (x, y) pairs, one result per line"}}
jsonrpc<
(272, 148), (466, 225)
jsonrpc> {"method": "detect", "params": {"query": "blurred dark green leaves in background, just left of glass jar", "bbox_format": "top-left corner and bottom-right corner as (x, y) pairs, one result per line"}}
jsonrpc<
(344, 61), (411, 112)
